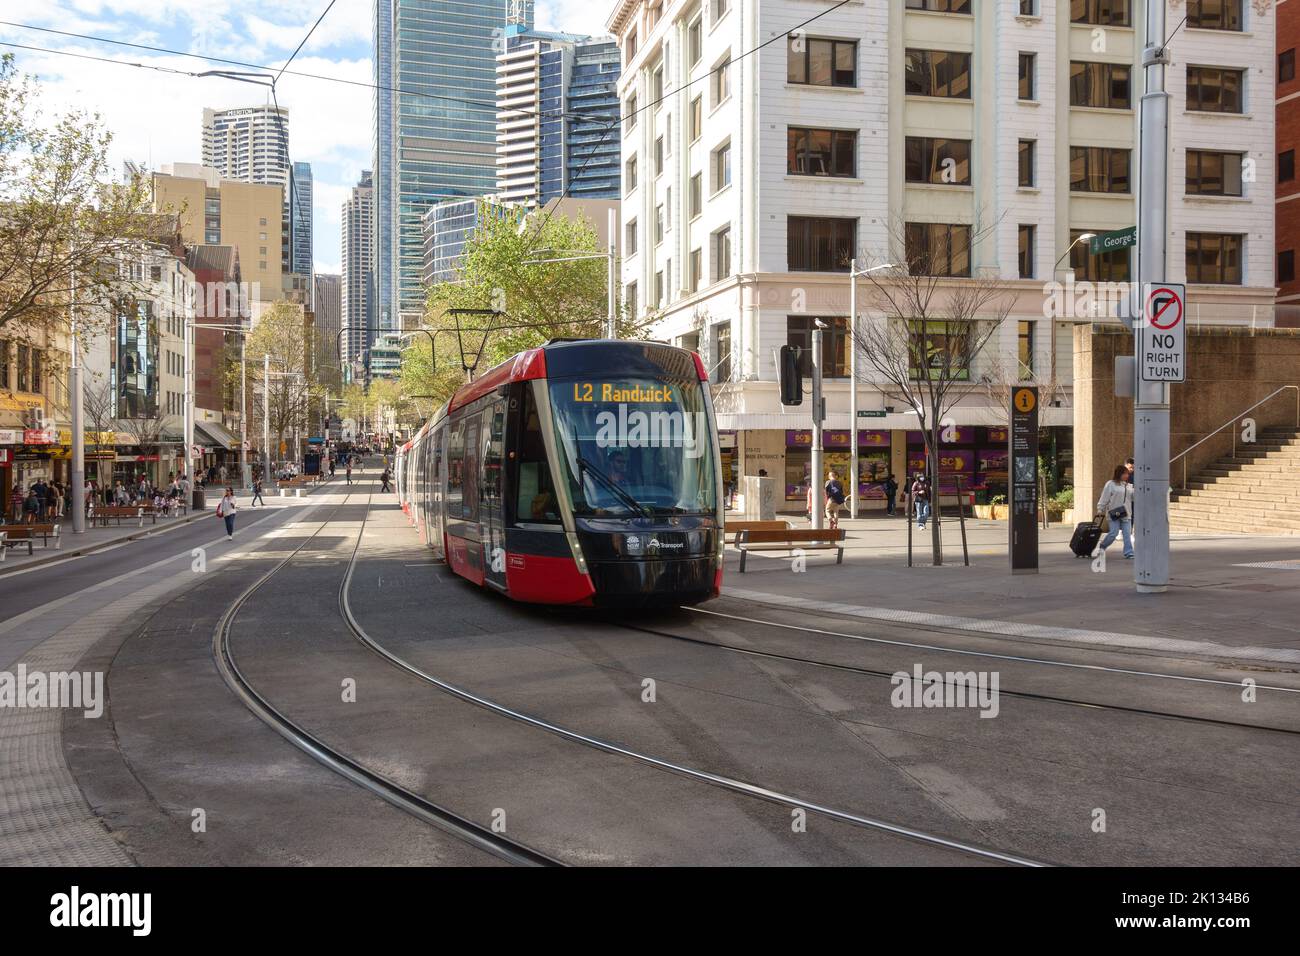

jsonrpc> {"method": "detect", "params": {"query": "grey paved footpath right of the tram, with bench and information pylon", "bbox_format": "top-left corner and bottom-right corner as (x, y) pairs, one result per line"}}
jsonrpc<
(723, 518), (1300, 667)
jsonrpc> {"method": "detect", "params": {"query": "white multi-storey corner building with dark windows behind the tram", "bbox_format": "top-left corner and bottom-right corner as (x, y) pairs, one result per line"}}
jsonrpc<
(607, 0), (1274, 506)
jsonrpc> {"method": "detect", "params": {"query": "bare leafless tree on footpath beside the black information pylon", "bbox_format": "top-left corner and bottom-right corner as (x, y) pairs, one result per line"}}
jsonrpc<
(855, 224), (1014, 566)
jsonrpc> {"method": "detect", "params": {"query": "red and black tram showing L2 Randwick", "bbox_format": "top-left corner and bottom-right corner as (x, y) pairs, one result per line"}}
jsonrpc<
(397, 339), (723, 605)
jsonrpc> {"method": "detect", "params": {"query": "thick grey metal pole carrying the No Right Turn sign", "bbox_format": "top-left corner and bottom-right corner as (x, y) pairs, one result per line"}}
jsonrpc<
(1134, 3), (1169, 593)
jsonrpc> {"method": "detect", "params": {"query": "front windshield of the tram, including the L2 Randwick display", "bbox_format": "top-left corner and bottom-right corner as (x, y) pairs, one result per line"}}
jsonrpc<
(550, 376), (718, 516)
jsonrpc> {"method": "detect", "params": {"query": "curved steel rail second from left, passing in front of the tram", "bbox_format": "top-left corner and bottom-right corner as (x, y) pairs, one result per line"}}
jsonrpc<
(339, 486), (1049, 866)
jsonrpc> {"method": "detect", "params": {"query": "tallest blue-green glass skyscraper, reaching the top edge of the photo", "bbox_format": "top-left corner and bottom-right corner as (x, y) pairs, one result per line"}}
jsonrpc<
(372, 0), (520, 329)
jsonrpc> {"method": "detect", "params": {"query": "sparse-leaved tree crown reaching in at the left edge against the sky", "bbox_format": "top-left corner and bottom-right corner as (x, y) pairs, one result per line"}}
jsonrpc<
(0, 55), (161, 330)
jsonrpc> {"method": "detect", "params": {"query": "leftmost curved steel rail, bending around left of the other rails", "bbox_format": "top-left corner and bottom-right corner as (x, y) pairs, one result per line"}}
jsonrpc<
(212, 481), (563, 866)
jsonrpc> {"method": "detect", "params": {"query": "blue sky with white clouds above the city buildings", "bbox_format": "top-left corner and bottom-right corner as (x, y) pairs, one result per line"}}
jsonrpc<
(0, 0), (595, 272)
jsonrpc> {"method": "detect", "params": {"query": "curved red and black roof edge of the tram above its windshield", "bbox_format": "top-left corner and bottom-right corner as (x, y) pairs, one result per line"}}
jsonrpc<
(447, 338), (709, 412)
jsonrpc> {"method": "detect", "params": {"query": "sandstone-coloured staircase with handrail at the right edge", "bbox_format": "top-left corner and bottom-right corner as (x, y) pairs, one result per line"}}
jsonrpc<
(1169, 428), (1300, 535)
